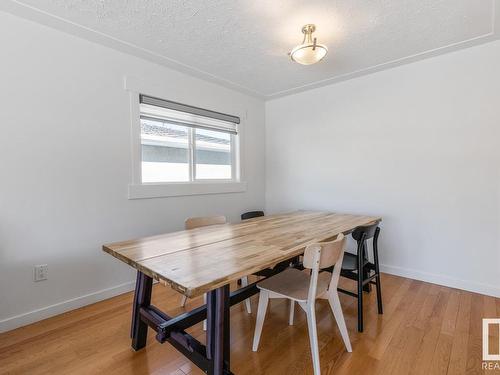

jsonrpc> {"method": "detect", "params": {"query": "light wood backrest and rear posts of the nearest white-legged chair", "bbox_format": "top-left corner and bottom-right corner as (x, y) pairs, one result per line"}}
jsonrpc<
(303, 233), (346, 302)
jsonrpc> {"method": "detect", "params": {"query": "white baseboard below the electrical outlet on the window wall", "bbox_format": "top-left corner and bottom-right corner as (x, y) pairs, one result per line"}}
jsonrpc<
(0, 281), (135, 333)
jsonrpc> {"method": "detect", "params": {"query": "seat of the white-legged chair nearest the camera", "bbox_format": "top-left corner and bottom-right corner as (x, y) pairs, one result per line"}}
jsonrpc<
(257, 268), (332, 302)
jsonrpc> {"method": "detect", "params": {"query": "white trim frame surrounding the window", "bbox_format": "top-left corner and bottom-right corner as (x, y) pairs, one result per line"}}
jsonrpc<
(125, 77), (247, 199)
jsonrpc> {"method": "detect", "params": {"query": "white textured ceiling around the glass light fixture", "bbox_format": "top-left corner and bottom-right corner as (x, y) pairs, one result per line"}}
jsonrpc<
(4, 0), (495, 97)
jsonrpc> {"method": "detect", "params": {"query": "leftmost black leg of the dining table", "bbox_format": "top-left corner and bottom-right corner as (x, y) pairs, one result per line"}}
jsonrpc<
(130, 271), (153, 350)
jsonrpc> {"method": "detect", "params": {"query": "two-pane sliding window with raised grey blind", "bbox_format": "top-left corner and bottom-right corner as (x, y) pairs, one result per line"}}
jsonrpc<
(140, 95), (240, 183)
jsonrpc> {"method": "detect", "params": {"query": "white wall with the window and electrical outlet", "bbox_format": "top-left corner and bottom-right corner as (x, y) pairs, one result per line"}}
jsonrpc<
(0, 12), (265, 331)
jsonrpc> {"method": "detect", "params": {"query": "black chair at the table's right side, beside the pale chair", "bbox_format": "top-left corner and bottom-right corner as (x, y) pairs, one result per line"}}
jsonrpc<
(338, 223), (383, 332)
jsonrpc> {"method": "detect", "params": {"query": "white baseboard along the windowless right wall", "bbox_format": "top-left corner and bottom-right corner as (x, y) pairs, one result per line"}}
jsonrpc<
(380, 264), (500, 298)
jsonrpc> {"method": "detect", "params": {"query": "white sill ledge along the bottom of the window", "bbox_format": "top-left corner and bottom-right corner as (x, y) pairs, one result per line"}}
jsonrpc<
(128, 181), (247, 199)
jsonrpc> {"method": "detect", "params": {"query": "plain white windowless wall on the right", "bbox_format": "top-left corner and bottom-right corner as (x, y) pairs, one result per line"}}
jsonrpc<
(266, 41), (500, 296)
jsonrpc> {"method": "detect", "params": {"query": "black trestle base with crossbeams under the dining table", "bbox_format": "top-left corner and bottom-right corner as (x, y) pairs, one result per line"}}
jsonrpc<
(130, 267), (292, 375)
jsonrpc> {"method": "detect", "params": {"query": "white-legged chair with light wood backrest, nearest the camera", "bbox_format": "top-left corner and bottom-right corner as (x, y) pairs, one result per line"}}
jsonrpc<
(252, 234), (352, 375)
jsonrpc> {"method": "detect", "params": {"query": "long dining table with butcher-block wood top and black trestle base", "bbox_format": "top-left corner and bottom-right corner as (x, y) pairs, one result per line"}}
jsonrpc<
(103, 210), (381, 375)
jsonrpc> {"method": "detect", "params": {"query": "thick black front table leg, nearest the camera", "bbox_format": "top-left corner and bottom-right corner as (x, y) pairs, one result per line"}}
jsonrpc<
(207, 285), (231, 375)
